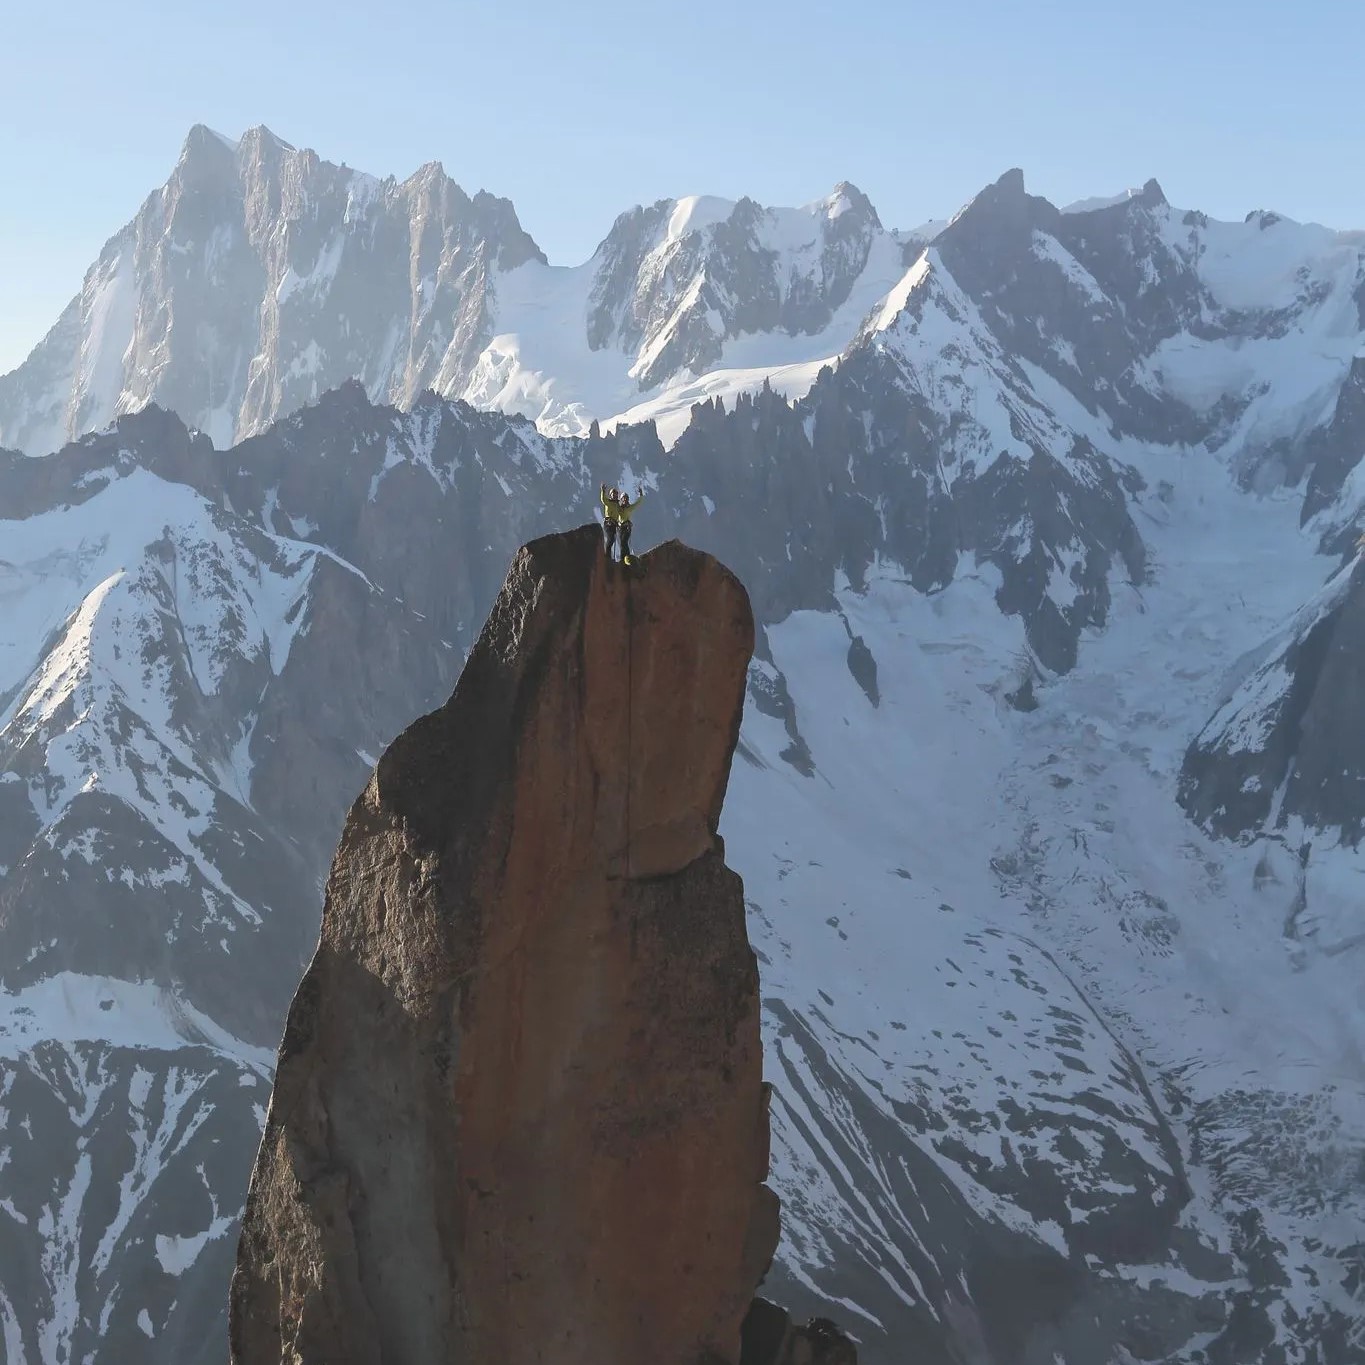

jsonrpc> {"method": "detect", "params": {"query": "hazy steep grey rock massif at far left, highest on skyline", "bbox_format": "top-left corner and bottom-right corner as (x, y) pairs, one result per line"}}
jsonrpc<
(0, 127), (543, 453)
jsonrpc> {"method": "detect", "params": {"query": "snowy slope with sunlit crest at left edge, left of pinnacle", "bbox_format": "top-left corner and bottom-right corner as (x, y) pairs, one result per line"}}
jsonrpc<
(0, 470), (315, 932)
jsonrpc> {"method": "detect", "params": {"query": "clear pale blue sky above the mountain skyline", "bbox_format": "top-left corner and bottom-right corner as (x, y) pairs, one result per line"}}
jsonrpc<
(0, 0), (1365, 373)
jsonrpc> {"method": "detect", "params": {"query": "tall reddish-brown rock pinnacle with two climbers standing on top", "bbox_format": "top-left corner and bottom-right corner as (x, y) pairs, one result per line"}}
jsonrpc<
(231, 527), (777, 1365)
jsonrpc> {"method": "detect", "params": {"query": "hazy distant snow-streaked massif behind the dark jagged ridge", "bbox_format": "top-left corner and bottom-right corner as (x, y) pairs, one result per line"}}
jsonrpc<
(0, 126), (934, 455)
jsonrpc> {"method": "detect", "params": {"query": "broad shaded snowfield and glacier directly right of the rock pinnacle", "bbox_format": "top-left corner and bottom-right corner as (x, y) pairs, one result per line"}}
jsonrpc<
(722, 368), (1365, 1362)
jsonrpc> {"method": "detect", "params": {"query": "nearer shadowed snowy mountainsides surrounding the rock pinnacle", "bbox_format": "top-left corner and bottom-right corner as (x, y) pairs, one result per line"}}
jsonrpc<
(0, 165), (1365, 1365)
